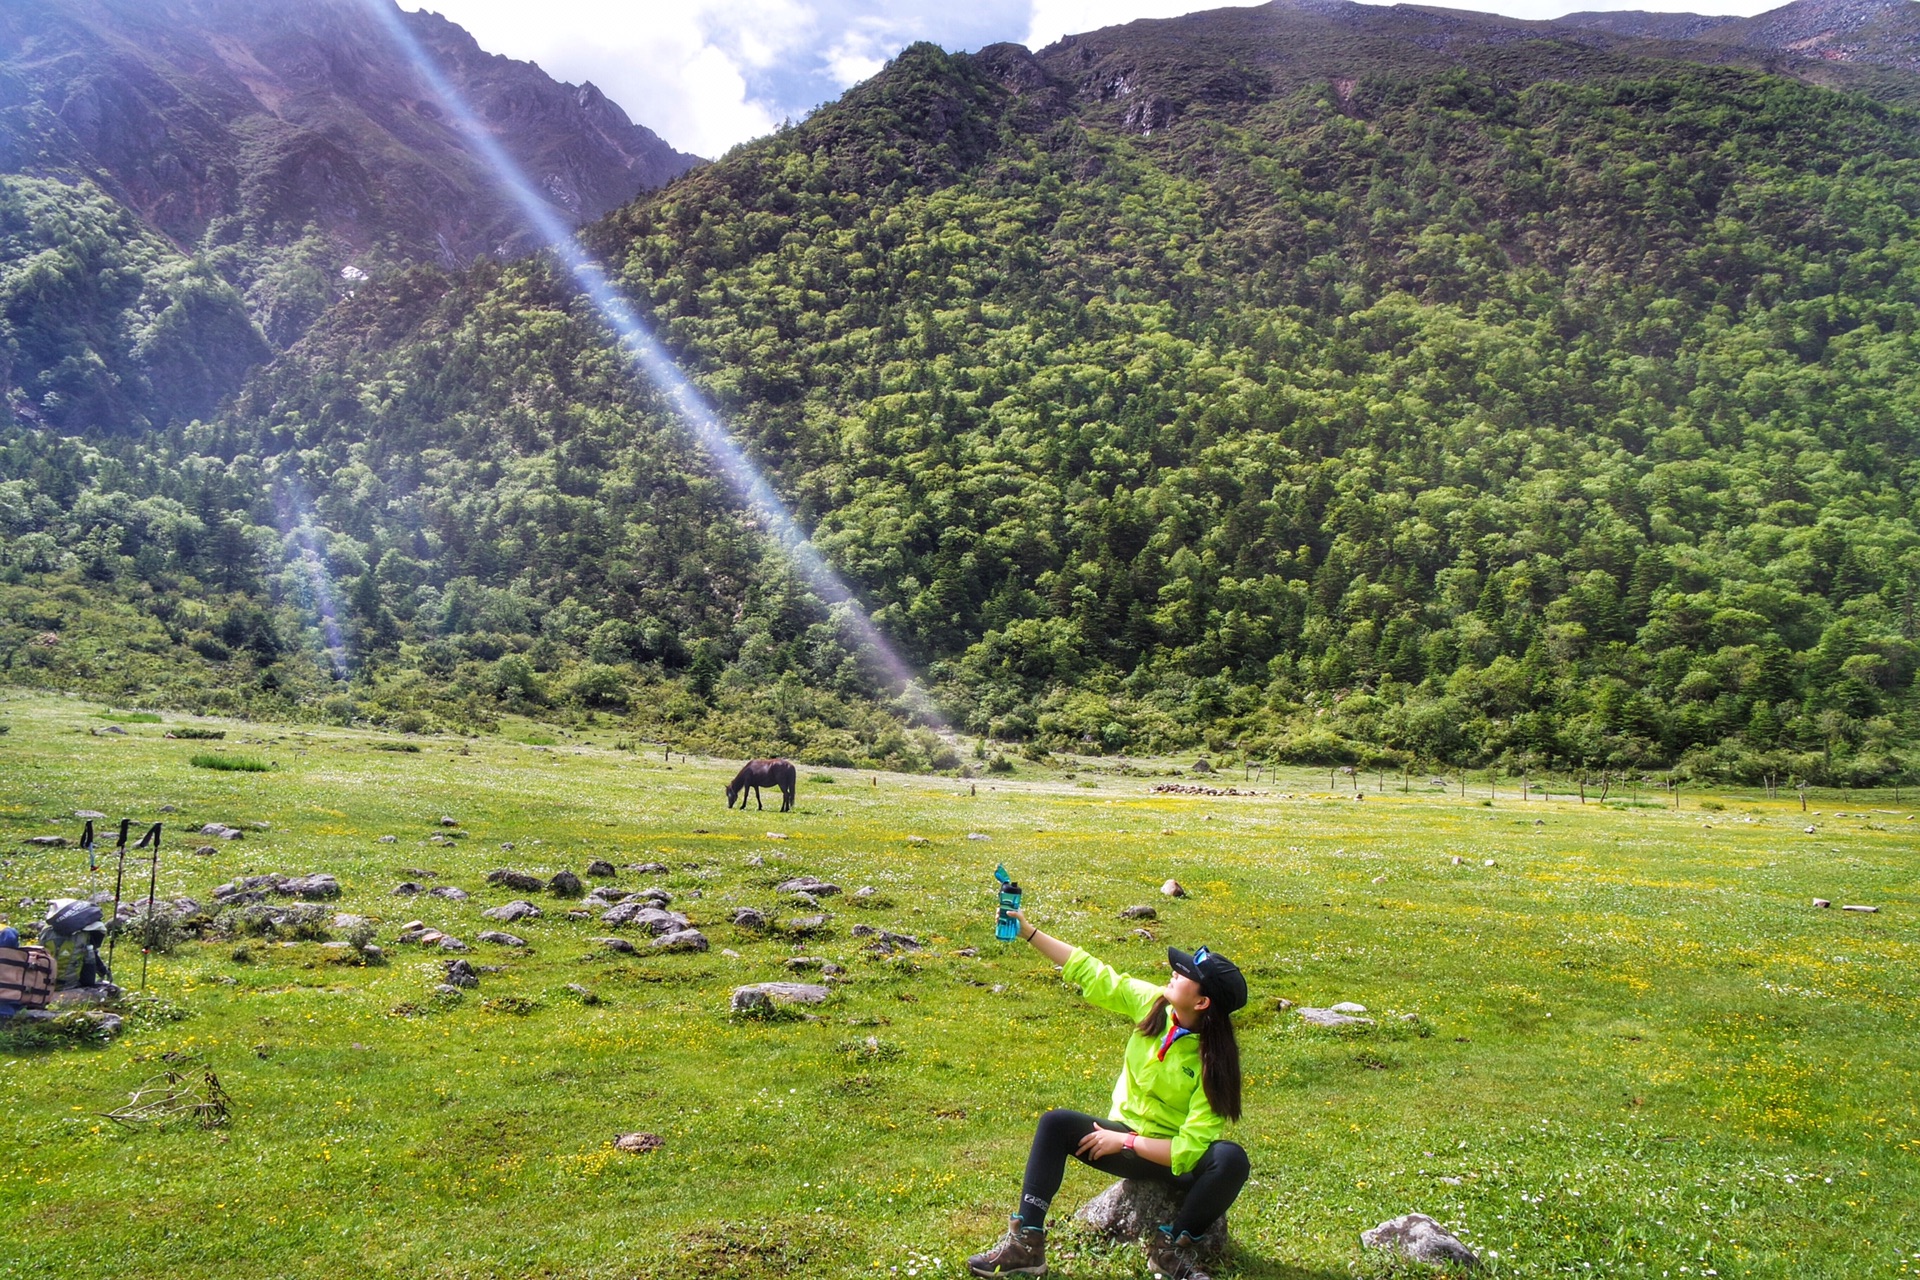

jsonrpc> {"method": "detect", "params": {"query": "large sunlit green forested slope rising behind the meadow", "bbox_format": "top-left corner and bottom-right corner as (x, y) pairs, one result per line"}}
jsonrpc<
(12, 4), (1920, 781)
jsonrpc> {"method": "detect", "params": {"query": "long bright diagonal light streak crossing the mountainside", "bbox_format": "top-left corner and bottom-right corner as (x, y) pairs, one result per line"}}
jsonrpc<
(363, 0), (945, 725)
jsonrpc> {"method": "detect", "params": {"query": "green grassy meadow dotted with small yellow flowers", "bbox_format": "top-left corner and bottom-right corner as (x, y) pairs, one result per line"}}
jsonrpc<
(0, 695), (1920, 1280)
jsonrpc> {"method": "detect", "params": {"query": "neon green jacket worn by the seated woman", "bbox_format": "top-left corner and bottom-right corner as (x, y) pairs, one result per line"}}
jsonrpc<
(1060, 946), (1227, 1174)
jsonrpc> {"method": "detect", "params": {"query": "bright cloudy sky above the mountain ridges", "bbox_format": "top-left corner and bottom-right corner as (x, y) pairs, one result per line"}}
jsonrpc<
(399, 0), (1786, 157)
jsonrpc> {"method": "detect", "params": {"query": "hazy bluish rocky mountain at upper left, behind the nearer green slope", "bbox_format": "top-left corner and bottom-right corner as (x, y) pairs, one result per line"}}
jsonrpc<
(0, 0), (697, 430)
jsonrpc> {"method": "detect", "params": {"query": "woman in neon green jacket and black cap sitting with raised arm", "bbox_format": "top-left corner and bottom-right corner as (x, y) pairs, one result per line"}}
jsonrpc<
(966, 912), (1248, 1280)
